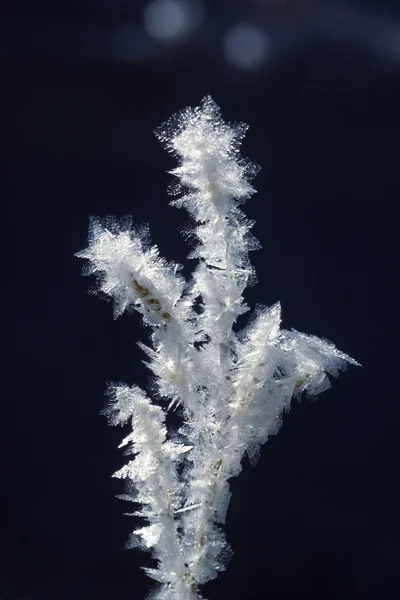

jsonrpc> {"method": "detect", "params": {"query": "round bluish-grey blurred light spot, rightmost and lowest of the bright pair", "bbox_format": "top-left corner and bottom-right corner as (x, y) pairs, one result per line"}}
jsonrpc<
(224, 25), (269, 69)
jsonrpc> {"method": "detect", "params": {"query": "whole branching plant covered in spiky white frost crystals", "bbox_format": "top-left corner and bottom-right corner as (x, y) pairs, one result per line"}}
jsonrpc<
(77, 97), (358, 600)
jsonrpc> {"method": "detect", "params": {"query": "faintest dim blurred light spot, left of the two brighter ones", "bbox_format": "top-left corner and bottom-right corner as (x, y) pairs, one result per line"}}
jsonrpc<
(110, 23), (158, 62)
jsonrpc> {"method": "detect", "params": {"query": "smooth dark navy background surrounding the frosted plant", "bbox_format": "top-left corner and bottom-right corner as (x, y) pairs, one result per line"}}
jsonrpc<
(0, 0), (400, 600)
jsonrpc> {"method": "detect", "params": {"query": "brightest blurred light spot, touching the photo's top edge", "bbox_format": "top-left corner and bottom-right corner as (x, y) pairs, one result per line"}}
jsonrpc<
(143, 0), (203, 42)
